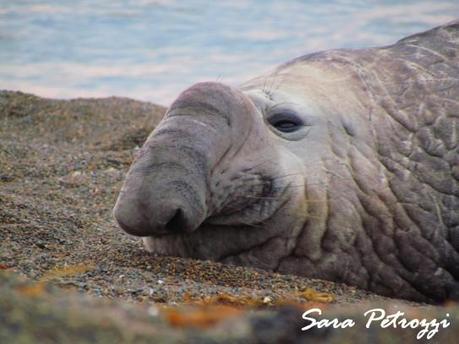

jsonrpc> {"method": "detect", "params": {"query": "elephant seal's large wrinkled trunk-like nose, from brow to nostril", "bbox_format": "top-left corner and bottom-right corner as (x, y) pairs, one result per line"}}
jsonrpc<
(114, 83), (253, 236)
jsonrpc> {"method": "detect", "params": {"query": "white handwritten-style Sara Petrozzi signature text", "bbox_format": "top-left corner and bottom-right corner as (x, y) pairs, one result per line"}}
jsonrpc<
(301, 308), (451, 339)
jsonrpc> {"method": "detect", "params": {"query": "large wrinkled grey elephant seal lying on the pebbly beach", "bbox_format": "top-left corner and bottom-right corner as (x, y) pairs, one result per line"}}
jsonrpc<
(114, 21), (459, 302)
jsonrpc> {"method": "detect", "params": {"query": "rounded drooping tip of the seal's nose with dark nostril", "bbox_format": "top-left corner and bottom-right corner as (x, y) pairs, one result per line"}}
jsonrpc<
(114, 192), (201, 236)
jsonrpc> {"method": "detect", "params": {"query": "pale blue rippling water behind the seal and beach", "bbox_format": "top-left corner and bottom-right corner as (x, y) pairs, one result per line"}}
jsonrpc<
(0, 0), (459, 105)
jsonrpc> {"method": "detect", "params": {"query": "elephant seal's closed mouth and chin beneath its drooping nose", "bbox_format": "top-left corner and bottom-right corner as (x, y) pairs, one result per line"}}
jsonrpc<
(142, 184), (296, 261)
